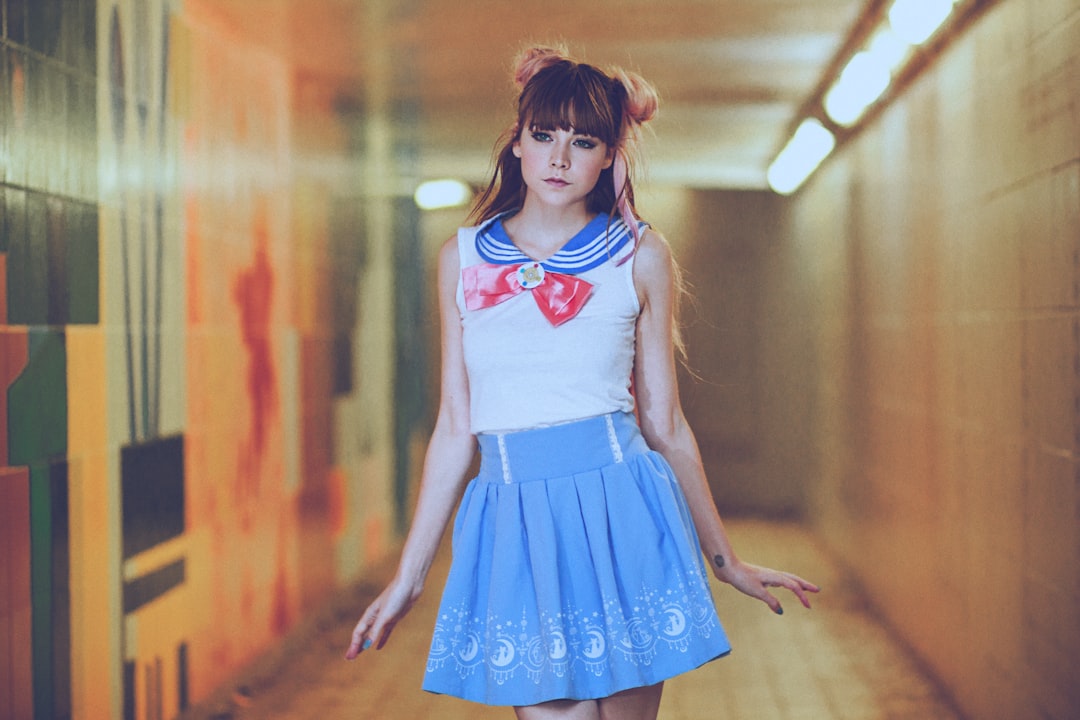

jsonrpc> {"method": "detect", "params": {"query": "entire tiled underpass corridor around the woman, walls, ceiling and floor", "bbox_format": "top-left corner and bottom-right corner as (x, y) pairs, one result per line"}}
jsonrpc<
(0, 0), (1080, 720)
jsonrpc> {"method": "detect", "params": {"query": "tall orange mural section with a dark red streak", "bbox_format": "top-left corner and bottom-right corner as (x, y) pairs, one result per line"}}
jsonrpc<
(177, 5), (300, 708)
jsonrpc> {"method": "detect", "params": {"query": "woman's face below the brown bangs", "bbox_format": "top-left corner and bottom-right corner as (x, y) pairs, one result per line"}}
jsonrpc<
(513, 127), (615, 205)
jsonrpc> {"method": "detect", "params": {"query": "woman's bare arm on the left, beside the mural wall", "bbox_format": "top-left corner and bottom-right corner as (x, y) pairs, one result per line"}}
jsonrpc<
(346, 237), (476, 660)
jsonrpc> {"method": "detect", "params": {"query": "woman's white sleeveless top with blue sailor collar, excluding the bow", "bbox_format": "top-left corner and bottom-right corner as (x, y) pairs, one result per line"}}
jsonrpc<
(457, 215), (644, 433)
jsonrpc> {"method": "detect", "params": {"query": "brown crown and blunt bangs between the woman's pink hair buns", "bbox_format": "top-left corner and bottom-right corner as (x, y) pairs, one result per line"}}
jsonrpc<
(517, 62), (622, 146)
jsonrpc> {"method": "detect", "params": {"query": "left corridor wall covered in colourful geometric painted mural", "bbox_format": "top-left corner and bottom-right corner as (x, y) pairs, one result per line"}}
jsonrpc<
(0, 0), (416, 720)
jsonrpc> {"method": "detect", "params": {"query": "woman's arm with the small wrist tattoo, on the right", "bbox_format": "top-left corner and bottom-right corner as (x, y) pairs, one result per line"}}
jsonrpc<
(634, 231), (818, 613)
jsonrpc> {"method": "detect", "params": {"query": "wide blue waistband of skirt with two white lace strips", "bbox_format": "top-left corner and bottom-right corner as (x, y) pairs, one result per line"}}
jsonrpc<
(476, 412), (648, 483)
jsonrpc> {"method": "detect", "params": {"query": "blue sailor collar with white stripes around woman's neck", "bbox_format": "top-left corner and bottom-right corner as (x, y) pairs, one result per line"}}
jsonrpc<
(476, 210), (645, 275)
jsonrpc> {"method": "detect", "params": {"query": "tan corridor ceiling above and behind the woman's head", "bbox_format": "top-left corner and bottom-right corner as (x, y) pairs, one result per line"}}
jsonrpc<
(212, 0), (866, 188)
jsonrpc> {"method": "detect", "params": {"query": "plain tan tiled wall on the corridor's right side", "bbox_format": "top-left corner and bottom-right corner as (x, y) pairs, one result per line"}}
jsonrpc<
(762, 0), (1080, 720)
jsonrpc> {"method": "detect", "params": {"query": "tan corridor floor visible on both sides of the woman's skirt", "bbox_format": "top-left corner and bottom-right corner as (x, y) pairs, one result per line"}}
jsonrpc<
(177, 520), (959, 720)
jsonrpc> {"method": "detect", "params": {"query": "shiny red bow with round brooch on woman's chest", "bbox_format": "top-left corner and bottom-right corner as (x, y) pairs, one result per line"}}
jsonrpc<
(461, 262), (593, 326)
